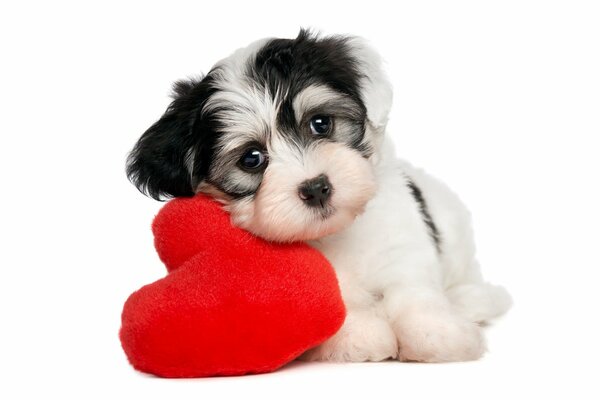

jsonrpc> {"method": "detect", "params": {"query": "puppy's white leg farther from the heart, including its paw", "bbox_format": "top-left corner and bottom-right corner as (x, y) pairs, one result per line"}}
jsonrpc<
(383, 267), (485, 362)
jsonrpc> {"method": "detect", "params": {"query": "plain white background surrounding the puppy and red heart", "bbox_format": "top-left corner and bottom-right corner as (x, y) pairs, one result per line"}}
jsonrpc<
(0, 0), (600, 399)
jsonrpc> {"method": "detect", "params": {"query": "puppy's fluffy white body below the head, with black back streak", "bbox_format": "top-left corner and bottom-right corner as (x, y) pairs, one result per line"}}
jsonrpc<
(304, 141), (510, 362)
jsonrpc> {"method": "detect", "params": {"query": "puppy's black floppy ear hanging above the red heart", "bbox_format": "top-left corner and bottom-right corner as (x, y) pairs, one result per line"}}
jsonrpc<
(127, 78), (212, 200)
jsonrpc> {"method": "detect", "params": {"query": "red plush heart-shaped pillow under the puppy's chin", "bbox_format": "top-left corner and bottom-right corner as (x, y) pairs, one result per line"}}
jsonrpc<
(120, 195), (345, 377)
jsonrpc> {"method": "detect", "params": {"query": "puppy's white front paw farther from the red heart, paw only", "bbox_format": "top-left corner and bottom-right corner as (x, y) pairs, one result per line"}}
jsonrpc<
(394, 313), (485, 362)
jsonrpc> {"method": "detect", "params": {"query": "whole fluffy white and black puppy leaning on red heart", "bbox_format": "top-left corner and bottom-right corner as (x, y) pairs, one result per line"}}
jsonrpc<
(127, 31), (510, 362)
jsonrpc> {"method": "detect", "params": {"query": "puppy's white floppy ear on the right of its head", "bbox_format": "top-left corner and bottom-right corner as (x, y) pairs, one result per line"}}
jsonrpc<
(348, 37), (392, 132)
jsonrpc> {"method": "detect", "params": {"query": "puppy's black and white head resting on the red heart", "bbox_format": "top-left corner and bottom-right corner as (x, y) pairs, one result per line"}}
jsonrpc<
(127, 31), (391, 241)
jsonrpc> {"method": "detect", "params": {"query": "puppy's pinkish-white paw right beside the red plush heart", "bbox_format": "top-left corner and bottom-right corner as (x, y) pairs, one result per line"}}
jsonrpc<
(300, 312), (398, 362)
